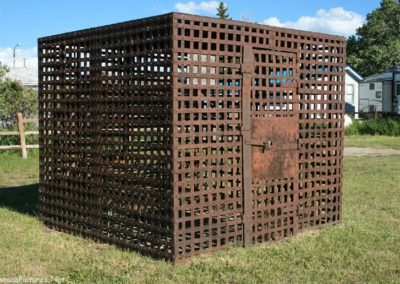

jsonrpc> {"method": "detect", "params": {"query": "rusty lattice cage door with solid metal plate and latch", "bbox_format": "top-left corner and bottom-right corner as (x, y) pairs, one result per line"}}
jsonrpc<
(242, 46), (299, 244)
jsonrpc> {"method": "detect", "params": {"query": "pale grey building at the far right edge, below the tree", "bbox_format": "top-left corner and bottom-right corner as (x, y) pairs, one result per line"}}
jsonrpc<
(360, 67), (400, 114)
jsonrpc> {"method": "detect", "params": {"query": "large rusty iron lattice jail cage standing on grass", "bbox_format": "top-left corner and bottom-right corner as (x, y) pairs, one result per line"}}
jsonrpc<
(38, 13), (345, 261)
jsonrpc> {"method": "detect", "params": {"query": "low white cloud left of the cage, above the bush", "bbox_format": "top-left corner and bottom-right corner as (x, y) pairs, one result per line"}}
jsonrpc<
(0, 47), (38, 72)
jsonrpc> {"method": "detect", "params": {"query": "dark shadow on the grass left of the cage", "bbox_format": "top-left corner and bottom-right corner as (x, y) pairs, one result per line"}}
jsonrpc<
(0, 184), (39, 216)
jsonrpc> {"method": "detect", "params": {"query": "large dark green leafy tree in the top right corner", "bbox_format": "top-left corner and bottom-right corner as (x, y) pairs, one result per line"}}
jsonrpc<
(347, 0), (400, 76)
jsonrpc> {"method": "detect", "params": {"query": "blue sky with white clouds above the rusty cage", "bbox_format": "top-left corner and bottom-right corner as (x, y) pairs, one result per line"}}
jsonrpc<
(0, 0), (380, 72)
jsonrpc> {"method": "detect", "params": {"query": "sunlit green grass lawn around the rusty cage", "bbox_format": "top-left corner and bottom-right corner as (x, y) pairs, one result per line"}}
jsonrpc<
(0, 143), (400, 283)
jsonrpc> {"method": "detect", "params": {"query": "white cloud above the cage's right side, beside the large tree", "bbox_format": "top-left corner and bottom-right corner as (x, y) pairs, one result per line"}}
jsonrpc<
(263, 7), (364, 37)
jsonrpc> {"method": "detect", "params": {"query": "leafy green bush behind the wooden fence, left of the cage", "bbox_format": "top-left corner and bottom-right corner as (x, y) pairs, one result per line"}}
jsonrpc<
(0, 62), (38, 129)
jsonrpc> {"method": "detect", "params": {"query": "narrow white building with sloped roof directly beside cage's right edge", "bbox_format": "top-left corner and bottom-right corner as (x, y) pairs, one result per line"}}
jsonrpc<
(345, 65), (363, 117)
